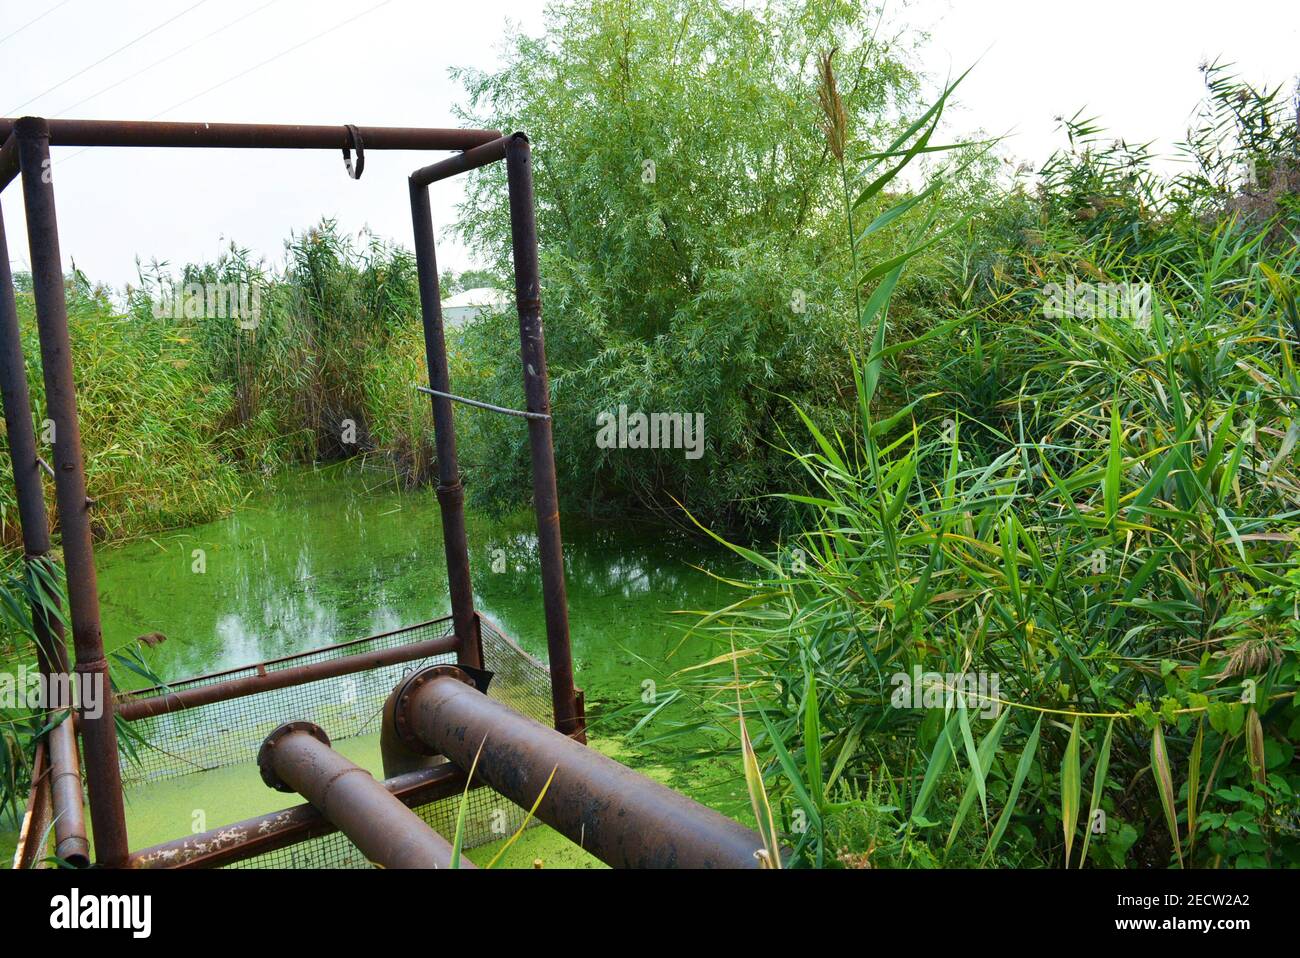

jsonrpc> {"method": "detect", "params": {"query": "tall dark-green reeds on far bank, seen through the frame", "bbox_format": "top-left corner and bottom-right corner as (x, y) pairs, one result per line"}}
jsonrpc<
(133, 220), (432, 478)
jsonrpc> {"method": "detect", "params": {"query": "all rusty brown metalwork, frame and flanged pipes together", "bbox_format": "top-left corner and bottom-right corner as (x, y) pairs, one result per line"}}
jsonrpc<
(0, 111), (644, 867)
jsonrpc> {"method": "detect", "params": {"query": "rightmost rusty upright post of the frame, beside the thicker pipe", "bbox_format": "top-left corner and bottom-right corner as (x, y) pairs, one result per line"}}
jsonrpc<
(506, 133), (585, 741)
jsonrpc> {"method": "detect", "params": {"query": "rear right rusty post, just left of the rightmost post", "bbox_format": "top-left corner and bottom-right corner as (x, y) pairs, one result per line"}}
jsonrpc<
(411, 181), (484, 668)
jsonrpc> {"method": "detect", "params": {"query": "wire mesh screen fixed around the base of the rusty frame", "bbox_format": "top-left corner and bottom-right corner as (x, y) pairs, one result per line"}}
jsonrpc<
(121, 619), (553, 868)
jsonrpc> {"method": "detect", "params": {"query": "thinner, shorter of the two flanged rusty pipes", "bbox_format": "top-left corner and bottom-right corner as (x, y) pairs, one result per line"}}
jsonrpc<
(257, 721), (473, 868)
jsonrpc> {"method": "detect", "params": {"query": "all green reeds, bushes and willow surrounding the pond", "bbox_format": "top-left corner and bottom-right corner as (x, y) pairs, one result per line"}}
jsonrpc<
(0, 0), (1300, 867)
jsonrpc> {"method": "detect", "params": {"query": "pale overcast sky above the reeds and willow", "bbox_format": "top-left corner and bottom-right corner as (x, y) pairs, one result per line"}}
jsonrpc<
(0, 0), (1300, 287)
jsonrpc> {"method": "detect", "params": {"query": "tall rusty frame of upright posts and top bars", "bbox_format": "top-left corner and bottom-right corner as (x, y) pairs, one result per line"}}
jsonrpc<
(0, 117), (585, 867)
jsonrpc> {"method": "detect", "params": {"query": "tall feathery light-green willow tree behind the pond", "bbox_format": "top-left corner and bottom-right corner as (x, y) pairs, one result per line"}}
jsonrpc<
(454, 0), (917, 526)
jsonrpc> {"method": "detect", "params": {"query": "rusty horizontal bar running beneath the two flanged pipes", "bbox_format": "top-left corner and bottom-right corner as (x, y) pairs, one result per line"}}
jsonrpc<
(129, 763), (481, 868)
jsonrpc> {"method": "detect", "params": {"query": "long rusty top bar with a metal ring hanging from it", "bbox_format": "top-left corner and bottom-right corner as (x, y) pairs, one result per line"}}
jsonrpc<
(0, 118), (501, 151)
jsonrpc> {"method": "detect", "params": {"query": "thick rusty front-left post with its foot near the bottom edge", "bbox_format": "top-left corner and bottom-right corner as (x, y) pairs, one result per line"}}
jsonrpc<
(13, 117), (127, 866)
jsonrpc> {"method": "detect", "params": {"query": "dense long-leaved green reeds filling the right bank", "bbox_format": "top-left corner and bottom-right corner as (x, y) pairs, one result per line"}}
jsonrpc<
(697, 61), (1300, 867)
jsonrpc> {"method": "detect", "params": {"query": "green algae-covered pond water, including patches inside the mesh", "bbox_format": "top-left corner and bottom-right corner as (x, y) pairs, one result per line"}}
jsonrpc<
(0, 467), (748, 867)
